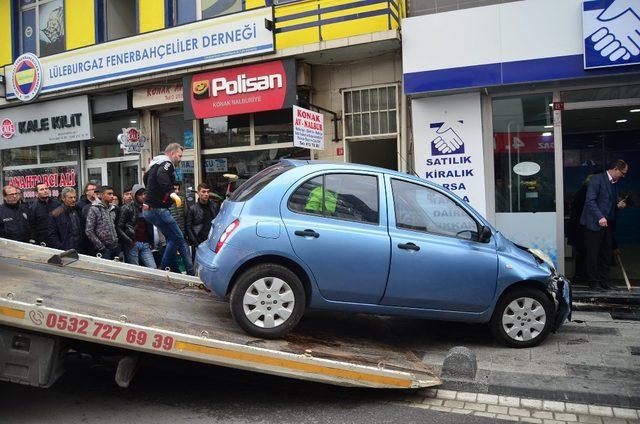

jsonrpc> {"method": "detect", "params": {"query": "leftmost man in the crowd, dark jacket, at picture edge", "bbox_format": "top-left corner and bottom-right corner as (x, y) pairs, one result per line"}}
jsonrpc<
(0, 186), (31, 243)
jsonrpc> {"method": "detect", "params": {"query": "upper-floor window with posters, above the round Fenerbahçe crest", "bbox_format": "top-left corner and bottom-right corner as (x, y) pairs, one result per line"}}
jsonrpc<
(20, 0), (65, 57)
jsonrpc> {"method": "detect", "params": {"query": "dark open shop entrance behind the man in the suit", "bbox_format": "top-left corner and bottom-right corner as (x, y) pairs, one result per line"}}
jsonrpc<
(562, 99), (640, 286)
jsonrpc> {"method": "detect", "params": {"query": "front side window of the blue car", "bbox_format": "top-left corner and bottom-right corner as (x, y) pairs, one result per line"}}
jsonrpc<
(391, 180), (479, 240)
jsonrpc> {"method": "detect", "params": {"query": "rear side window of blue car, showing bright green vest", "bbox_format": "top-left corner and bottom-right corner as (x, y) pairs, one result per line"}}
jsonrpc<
(289, 174), (380, 224)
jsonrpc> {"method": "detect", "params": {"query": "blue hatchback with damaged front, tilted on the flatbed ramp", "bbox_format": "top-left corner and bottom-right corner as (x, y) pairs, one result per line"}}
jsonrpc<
(196, 160), (571, 347)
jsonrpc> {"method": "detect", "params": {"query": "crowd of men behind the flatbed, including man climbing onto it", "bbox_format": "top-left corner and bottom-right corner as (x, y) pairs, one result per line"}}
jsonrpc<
(0, 143), (219, 275)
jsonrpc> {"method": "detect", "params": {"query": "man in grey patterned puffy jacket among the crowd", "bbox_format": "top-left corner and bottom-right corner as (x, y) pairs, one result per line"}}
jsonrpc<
(85, 186), (120, 259)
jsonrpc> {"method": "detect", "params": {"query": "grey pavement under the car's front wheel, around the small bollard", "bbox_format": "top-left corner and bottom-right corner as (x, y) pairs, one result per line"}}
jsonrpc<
(392, 311), (640, 408)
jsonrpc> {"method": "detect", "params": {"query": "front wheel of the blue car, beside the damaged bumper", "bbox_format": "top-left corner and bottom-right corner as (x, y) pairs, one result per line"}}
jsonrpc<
(490, 287), (555, 348)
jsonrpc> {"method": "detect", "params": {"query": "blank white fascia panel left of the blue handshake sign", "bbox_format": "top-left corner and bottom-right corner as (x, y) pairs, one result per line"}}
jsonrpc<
(402, 0), (583, 73)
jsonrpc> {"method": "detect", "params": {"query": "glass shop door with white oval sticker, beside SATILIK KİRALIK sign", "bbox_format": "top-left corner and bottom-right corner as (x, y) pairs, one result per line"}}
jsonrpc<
(492, 93), (558, 264)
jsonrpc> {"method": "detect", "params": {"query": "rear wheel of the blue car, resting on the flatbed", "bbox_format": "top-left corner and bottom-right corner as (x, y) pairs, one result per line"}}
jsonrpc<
(230, 264), (306, 339)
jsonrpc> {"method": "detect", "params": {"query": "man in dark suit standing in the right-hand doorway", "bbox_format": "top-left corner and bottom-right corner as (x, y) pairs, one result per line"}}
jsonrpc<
(580, 159), (629, 290)
